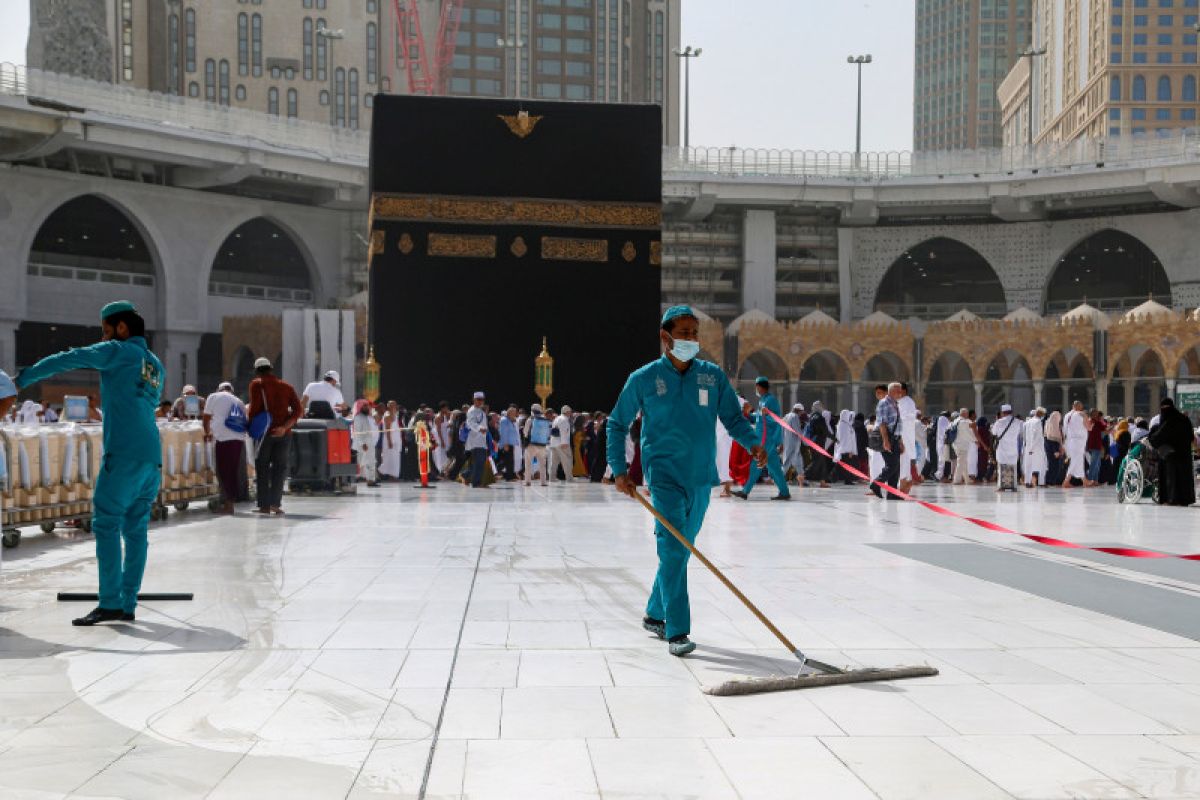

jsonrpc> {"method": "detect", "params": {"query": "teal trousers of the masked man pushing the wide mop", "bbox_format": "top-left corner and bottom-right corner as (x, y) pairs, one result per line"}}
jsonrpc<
(646, 483), (712, 638)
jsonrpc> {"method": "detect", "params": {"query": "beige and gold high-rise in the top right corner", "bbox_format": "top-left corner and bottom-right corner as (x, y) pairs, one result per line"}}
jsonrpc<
(1006, 0), (1200, 142)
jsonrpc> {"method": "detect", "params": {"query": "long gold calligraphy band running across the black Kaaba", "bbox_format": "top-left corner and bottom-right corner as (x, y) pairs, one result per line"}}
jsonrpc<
(371, 194), (662, 230)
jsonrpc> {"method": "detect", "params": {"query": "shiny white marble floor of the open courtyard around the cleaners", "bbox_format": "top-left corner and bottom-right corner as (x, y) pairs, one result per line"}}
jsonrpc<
(0, 485), (1200, 800)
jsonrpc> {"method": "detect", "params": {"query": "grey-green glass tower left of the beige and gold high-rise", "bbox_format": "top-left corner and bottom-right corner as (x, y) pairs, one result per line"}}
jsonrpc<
(913, 0), (1036, 151)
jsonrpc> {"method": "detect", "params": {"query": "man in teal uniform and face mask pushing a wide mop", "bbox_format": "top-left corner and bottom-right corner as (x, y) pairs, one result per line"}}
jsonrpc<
(606, 306), (764, 656)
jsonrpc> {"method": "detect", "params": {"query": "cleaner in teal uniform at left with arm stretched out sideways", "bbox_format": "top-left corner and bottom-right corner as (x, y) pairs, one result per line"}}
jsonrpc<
(17, 300), (163, 625)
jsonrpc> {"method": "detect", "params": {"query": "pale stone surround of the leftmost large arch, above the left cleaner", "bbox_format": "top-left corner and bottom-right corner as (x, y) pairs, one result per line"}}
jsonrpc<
(18, 187), (168, 330)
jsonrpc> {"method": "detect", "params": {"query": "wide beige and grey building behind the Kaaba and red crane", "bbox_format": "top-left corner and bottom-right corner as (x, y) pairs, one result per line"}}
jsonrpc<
(26, 0), (682, 144)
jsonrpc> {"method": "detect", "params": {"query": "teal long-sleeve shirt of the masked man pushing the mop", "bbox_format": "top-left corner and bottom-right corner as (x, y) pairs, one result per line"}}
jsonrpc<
(606, 355), (758, 489)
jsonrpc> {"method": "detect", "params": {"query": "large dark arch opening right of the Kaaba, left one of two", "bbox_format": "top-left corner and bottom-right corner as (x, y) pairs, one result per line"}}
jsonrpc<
(874, 236), (1007, 319)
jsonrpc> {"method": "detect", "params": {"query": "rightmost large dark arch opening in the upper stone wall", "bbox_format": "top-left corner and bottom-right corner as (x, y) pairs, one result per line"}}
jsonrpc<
(1043, 228), (1171, 314)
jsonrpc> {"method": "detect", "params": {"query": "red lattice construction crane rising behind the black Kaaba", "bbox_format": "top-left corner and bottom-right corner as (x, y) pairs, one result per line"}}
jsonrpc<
(388, 0), (463, 95)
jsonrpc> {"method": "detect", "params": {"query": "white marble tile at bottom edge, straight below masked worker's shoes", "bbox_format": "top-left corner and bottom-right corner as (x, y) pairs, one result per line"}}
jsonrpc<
(588, 739), (738, 800)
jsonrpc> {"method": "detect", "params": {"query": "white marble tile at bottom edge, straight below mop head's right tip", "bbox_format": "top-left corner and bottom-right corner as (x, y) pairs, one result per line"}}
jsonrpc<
(822, 736), (1010, 800)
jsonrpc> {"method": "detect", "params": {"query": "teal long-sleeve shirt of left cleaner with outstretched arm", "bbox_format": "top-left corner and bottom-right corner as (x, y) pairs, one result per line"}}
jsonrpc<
(17, 336), (163, 464)
